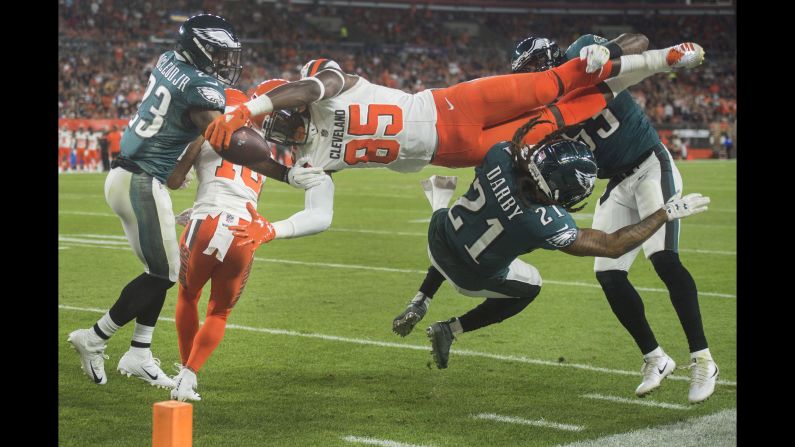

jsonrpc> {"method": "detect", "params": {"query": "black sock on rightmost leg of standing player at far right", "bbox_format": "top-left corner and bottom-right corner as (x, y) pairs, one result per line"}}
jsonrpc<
(650, 250), (707, 352)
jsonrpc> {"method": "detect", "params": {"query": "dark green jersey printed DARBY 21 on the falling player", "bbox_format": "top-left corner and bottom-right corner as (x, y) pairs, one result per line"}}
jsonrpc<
(436, 142), (578, 276)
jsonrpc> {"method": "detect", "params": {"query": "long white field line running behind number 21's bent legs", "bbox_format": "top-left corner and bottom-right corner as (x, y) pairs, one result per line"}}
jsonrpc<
(58, 236), (737, 298)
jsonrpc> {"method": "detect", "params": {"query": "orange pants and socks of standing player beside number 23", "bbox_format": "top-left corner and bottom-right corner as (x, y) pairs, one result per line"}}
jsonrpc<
(175, 215), (254, 372)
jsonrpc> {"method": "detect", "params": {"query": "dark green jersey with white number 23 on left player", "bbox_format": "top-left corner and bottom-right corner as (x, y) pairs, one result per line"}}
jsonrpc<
(121, 51), (226, 183)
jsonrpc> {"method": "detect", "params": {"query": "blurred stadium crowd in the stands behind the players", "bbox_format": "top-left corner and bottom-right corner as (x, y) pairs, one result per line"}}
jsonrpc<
(58, 0), (737, 172)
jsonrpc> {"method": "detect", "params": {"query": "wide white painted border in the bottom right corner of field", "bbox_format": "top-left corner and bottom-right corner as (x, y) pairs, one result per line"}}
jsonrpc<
(558, 408), (737, 447)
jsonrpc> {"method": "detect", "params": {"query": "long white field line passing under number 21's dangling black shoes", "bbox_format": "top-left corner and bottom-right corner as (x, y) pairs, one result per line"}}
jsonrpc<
(58, 304), (737, 386)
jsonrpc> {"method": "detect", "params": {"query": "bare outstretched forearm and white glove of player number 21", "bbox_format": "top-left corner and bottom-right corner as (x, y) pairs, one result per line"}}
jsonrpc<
(561, 193), (709, 259)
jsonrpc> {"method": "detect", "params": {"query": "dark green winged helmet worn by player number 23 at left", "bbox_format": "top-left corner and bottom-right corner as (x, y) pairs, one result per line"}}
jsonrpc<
(176, 14), (243, 86)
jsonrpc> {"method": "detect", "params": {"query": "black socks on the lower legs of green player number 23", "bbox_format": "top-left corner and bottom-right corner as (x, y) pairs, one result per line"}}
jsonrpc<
(109, 273), (174, 326)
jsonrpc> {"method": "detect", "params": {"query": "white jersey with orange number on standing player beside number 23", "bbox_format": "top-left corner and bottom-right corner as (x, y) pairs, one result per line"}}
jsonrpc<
(191, 141), (265, 221)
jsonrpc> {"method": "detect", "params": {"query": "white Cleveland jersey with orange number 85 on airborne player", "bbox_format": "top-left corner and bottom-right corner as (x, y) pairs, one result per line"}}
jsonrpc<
(296, 77), (437, 172)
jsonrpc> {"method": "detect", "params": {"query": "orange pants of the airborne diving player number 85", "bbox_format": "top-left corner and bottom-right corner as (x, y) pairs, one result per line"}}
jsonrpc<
(431, 59), (612, 168)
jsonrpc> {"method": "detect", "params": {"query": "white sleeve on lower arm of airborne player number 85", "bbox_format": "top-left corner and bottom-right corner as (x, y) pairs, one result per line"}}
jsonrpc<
(273, 176), (334, 239)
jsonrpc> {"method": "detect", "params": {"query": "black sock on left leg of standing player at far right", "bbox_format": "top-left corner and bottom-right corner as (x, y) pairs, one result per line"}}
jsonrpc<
(596, 270), (659, 354)
